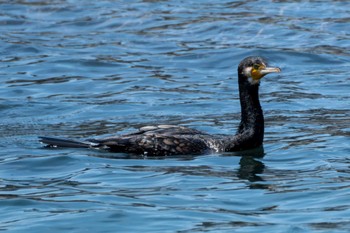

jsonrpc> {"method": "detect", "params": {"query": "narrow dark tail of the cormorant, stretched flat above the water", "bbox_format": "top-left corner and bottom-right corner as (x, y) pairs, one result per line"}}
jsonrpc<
(39, 137), (98, 148)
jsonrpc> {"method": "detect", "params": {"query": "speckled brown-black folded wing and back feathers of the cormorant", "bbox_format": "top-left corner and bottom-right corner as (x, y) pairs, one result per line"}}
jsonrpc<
(89, 125), (227, 156)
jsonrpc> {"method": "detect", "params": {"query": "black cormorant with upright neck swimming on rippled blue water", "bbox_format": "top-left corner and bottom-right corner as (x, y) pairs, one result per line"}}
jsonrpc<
(39, 56), (281, 156)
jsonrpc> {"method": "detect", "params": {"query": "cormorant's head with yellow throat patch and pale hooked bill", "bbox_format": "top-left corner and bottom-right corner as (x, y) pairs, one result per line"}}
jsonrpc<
(238, 57), (281, 85)
